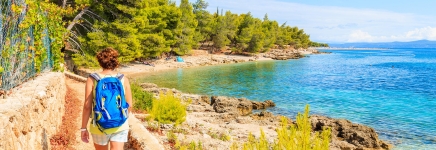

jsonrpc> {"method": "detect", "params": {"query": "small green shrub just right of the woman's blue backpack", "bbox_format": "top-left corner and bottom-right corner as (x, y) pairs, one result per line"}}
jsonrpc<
(130, 82), (153, 112)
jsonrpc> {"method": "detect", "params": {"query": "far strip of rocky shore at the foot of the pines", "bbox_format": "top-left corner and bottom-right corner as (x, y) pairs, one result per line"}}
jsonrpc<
(65, 49), (325, 77)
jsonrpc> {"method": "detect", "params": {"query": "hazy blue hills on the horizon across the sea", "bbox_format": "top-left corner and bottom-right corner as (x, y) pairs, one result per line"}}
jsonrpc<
(328, 40), (436, 48)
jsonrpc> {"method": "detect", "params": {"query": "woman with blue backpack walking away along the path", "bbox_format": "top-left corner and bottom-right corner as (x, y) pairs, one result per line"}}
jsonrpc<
(80, 48), (132, 150)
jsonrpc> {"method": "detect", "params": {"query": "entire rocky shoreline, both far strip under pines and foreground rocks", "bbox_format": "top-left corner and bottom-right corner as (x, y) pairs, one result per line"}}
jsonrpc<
(66, 49), (392, 150)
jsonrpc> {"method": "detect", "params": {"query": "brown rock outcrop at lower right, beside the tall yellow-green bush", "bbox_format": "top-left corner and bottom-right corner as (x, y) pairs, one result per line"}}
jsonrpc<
(310, 115), (391, 150)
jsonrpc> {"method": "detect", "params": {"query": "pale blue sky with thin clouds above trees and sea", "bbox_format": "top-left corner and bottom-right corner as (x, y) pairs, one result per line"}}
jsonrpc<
(190, 0), (436, 43)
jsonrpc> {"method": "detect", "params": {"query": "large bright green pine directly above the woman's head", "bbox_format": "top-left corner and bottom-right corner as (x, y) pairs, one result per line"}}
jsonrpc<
(76, 0), (182, 63)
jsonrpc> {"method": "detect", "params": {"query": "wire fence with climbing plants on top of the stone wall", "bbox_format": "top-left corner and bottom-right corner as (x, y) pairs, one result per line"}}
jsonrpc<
(0, 0), (54, 91)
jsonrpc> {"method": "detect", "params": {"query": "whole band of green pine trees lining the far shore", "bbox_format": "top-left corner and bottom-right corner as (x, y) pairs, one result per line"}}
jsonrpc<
(70, 0), (324, 67)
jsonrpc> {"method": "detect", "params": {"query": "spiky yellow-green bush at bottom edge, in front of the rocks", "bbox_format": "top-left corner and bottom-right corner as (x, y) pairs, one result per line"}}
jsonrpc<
(235, 105), (331, 150)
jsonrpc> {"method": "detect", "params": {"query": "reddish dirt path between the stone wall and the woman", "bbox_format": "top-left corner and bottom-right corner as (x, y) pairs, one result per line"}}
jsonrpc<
(65, 78), (94, 150)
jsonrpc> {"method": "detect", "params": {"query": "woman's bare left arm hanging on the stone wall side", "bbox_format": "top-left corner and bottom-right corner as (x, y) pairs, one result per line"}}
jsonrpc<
(81, 77), (94, 129)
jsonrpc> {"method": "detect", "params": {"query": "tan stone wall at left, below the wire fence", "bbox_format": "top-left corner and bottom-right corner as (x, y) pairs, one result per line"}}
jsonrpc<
(0, 72), (66, 150)
